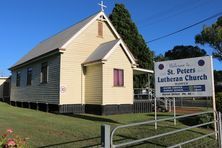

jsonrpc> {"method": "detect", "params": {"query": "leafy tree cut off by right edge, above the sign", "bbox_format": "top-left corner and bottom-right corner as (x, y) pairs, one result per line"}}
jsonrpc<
(195, 16), (222, 61)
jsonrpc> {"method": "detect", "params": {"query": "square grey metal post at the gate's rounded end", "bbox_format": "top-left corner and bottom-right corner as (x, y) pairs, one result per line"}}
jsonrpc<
(101, 124), (110, 148)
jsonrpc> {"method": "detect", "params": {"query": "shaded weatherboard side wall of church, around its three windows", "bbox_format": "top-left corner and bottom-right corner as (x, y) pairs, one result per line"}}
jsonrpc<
(11, 55), (60, 104)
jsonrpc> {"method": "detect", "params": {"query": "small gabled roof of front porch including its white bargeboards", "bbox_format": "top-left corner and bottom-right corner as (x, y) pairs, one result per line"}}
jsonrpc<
(83, 39), (136, 65)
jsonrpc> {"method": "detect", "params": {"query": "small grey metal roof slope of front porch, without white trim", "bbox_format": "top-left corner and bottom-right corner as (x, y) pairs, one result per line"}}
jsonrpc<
(83, 39), (120, 64)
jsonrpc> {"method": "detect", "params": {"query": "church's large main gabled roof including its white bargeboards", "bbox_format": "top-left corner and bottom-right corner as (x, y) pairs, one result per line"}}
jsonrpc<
(10, 11), (135, 69)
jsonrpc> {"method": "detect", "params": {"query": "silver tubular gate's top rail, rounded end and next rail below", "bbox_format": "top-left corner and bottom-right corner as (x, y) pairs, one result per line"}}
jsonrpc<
(110, 111), (216, 147)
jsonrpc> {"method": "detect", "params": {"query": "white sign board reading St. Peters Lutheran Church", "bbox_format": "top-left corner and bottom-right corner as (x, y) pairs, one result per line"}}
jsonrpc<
(154, 56), (213, 97)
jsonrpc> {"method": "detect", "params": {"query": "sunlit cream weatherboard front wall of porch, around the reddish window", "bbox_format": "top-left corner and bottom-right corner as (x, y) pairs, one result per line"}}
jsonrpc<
(103, 46), (133, 105)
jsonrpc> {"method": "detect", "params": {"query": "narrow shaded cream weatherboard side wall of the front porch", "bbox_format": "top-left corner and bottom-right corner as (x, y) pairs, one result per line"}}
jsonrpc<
(85, 64), (102, 104)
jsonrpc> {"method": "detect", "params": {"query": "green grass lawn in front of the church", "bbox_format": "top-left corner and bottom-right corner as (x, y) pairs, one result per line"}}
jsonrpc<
(0, 103), (219, 147)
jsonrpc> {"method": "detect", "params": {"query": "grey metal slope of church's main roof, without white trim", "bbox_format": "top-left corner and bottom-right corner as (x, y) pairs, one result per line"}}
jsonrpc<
(11, 12), (99, 68)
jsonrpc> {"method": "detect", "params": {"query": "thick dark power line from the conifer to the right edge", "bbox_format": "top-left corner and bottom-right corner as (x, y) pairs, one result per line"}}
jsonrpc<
(146, 12), (222, 43)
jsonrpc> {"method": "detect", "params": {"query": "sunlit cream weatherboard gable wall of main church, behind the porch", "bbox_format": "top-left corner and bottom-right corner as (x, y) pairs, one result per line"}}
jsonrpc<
(60, 21), (116, 104)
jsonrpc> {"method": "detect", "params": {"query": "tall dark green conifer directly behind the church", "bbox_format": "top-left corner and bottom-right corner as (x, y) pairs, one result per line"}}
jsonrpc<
(109, 4), (153, 87)
